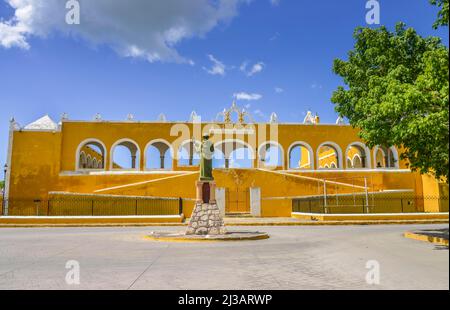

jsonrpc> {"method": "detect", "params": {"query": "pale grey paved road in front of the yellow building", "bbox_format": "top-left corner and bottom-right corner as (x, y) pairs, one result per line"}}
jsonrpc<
(0, 225), (449, 290)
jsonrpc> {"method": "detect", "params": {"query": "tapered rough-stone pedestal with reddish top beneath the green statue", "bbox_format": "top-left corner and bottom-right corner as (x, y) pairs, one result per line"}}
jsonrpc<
(186, 181), (226, 235)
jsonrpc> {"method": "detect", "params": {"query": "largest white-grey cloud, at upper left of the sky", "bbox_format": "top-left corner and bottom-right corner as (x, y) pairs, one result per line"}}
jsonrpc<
(0, 0), (250, 64)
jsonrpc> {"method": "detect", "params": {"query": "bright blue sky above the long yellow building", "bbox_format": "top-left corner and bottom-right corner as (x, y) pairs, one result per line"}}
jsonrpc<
(0, 0), (448, 167)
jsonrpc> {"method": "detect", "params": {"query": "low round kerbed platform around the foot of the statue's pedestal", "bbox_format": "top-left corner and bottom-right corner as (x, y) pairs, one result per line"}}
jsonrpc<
(146, 231), (269, 242)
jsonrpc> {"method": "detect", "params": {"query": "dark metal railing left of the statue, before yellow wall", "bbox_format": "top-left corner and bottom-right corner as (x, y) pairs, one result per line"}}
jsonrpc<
(1, 196), (183, 216)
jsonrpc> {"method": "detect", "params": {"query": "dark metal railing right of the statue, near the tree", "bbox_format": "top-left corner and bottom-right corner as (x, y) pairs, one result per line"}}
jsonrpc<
(292, 194), (449, 214)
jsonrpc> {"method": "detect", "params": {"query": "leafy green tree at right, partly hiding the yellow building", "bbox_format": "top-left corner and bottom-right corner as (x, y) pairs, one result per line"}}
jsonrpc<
(332, 23), (449, 182)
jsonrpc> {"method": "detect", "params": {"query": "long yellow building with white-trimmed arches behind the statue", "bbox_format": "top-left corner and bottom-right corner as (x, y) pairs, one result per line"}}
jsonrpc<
(3, 104), (448, 217)
